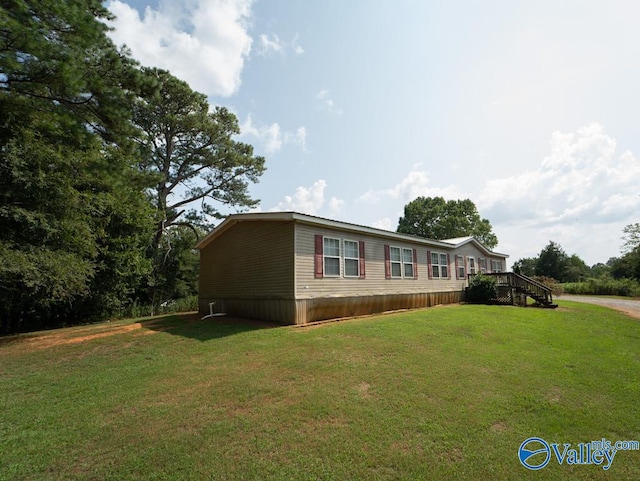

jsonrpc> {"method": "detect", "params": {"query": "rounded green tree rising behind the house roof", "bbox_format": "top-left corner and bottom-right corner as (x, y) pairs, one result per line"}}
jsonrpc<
(397, 197), (498, 249)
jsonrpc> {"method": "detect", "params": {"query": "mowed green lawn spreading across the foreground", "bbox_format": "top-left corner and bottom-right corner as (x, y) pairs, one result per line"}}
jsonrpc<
(0, 301), (640, 480)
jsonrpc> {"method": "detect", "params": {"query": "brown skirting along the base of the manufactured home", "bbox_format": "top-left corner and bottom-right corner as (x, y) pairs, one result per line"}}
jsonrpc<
(199, 291), (464, 324)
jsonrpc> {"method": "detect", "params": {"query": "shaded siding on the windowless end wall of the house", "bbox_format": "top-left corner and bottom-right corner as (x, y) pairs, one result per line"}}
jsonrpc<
(200, 221), (294, 300)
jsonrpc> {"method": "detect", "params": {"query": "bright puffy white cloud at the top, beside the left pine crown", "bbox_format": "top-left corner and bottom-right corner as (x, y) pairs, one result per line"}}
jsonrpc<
(107, 0), (252, 96)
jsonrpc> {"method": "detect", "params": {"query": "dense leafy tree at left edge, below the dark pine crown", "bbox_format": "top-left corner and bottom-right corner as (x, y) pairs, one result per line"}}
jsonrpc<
(0, 113), (151, 332)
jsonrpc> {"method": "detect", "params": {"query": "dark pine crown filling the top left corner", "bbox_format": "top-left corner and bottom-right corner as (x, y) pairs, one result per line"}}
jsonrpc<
(0, 0), (138, 142)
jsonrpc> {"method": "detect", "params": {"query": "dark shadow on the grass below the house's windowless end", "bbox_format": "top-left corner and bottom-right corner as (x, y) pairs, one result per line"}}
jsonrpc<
(140, 313), (282, 341)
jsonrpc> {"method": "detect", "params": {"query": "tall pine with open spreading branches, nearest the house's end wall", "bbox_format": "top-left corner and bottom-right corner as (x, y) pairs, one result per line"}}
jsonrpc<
(134, 68), (265, 302)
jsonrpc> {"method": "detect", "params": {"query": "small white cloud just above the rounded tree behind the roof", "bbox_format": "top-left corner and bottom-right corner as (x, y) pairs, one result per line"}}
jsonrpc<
(358, 170), (467, 204)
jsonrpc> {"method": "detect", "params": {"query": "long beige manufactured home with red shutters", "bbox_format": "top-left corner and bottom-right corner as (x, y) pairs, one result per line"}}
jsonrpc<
(197, 212), (508, 324)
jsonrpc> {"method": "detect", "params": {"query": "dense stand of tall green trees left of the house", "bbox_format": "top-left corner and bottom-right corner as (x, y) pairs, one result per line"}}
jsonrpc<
(0, 0), (265, 333)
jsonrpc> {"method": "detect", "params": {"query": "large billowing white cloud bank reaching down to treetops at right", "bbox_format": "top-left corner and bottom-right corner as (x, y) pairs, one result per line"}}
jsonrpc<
(477, 123), (640, 264)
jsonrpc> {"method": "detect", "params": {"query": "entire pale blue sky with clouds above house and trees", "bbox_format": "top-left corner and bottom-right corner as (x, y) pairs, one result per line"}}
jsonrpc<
(107, 0), (640, 264)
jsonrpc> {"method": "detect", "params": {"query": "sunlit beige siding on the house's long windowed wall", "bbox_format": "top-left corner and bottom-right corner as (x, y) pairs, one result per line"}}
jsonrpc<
(295, 223), (466, 299)
